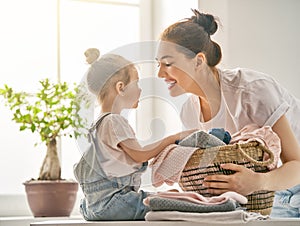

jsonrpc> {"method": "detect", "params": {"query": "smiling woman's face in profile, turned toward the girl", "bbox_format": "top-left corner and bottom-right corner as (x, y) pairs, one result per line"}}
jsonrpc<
(156, 42), (195, 97)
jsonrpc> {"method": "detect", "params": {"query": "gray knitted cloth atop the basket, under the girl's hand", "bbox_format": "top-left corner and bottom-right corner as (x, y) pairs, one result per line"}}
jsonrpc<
(178, 131), (226, 148)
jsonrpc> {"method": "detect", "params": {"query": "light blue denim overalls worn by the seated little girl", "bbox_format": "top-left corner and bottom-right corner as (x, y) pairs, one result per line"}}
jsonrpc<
(74, 115), (149, 220)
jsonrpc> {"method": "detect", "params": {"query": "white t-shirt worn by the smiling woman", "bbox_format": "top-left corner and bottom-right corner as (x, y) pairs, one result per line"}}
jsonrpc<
(181, 68), (300, 141)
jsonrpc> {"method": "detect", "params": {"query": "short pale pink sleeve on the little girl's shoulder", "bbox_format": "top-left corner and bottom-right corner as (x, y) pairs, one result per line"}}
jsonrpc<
(98, 114), (136, 149)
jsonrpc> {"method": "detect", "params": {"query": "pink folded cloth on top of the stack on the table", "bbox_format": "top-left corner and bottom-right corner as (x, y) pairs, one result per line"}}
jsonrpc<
(143, 191), (248, 205)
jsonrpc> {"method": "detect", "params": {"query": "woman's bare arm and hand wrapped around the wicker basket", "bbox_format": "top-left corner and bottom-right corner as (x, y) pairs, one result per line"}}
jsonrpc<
(203, 116), (300, 195)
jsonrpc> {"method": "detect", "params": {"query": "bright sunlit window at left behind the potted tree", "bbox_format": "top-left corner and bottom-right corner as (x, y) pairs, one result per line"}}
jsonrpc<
(0, 0), (140, 194)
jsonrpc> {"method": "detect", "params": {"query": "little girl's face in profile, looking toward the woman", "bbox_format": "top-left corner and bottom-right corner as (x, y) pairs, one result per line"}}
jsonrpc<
(124, 68), (141, 108)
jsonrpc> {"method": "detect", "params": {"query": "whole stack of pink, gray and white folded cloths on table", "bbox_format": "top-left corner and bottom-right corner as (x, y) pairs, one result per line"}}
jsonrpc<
(144, 192), (268, 223)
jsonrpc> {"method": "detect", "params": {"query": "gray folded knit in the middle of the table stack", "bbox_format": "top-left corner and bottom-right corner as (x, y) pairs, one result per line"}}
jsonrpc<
(149, 197), (240, 213)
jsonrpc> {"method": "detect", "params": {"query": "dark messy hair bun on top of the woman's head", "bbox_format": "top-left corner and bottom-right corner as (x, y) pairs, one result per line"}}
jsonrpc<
(189, 9), (218, 35)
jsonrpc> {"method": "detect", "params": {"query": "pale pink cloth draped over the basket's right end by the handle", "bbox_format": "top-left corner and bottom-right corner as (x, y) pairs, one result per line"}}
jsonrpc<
(230, 124), (281, 170)
